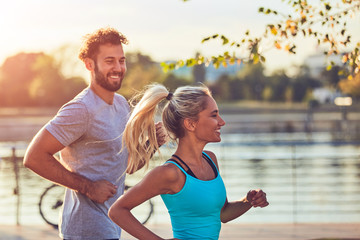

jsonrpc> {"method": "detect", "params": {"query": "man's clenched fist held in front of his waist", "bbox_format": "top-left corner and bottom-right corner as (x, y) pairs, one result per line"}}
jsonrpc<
(84, 180), (117, 203)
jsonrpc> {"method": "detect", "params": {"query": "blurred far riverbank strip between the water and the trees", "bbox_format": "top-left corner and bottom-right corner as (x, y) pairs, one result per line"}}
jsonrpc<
(0, 102), (360, 141)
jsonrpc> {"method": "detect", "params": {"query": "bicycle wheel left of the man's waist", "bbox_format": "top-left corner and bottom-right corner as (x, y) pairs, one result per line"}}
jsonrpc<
(39, 184), (64, 229)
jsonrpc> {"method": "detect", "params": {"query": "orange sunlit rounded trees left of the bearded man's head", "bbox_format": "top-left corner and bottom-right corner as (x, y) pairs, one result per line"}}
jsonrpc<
(0, 53), (87, 107)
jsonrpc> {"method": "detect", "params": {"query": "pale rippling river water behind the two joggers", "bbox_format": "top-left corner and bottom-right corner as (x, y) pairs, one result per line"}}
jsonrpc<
(0, 133), (360, 224)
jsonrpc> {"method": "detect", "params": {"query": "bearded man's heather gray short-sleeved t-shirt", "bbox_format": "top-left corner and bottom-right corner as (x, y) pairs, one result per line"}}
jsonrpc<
(46, 88), (130, 240)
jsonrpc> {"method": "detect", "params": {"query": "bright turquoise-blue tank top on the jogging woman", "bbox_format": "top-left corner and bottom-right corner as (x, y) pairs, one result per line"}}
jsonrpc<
(161, 153), (226, 240)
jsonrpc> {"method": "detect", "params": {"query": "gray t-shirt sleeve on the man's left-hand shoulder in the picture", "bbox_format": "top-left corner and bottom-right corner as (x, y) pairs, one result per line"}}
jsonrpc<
(45, 102), (89, 146)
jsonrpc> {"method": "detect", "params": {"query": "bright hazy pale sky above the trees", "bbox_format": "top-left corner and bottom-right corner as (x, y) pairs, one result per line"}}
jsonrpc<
(0, 0), (360, 76)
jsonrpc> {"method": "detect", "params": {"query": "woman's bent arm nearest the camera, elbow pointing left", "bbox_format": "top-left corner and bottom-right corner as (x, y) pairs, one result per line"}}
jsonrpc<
(109, 165), (179, 240)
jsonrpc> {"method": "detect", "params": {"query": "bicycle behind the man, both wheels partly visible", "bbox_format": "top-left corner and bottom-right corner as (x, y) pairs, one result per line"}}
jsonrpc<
(39, 184), (154, 229)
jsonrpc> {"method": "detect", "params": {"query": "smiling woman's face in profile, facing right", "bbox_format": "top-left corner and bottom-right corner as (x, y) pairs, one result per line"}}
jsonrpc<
(194, 97), (225, 143)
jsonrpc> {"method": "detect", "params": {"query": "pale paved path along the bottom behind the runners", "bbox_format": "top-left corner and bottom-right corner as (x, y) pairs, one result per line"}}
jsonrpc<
(0, 223), (360, 240)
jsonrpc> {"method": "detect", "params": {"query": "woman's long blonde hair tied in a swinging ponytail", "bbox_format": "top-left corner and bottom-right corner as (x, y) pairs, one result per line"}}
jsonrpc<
(123, 84), (211, 172)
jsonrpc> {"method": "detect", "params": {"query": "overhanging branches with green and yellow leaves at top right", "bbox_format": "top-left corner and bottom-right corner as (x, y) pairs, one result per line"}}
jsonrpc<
(172, 0), (360, 77)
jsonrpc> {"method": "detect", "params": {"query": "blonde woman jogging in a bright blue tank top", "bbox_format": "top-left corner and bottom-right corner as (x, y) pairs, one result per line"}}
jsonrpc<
(109, 85), (269, 240)
